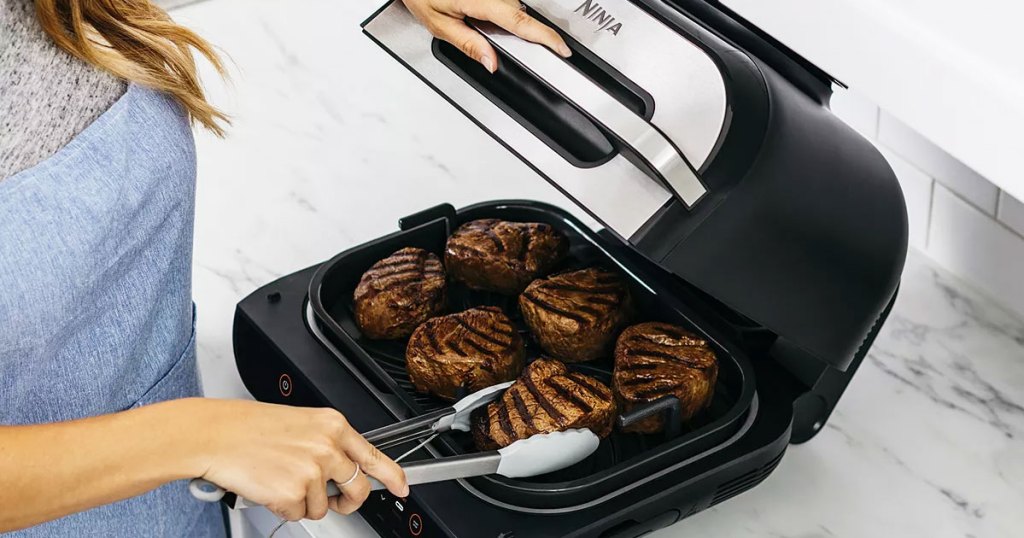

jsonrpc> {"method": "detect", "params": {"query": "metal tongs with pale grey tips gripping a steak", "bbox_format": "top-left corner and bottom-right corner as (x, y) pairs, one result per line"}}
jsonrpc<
(188, 381), (599, 508)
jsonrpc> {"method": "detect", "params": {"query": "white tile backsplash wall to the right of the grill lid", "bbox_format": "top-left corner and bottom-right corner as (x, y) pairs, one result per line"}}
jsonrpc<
(831, 88), (1024, 329)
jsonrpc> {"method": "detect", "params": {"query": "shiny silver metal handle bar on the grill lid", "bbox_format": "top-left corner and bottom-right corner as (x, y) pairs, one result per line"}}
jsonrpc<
(466, 19), (708, 208)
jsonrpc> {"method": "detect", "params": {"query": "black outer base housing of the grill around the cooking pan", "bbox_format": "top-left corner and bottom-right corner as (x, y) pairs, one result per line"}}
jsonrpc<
(233, 260), (806, 538)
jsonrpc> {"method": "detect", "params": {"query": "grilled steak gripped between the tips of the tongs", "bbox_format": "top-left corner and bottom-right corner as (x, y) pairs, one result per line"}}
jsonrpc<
(471, 359), (615, 450)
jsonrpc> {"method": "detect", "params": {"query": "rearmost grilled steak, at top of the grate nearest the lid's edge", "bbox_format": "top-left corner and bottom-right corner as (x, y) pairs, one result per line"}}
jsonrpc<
(444, 218), (569, 295)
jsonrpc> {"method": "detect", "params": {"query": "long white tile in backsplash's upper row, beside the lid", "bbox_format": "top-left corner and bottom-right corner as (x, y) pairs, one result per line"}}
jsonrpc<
(878, 111), (999, 216)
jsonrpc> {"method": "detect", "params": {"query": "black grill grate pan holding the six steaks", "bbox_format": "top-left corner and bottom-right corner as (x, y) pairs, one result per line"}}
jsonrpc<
(310, 204), (753, 500)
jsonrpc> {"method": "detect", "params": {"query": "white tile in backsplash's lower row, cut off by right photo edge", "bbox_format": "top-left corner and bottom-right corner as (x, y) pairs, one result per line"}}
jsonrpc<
(927, 183), (1024, 316)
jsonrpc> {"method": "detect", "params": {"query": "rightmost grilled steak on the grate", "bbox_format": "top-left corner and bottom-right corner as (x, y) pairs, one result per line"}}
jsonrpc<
(611, 322), (718, 433)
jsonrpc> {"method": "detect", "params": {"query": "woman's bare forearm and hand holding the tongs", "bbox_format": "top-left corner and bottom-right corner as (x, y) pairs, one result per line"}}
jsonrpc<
(0, 398), (409, 533)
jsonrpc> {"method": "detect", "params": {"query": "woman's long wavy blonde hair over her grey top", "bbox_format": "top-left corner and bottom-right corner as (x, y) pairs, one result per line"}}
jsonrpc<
(35, 0), (228, 136)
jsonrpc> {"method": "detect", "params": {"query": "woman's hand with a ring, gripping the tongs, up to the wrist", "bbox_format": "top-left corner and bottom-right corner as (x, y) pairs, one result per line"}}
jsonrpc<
(187, 399), (409, 521)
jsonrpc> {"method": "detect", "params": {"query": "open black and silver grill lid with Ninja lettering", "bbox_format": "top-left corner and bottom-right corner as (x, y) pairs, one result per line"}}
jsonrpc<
(364, 0), (906, 369)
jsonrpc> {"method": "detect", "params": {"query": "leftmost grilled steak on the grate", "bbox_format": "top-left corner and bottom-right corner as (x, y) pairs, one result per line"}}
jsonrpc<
(352, 248), (444, 339)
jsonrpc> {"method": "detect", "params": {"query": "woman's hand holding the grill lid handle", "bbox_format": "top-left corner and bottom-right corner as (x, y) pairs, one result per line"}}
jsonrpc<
(402, 0), (572, 73)
